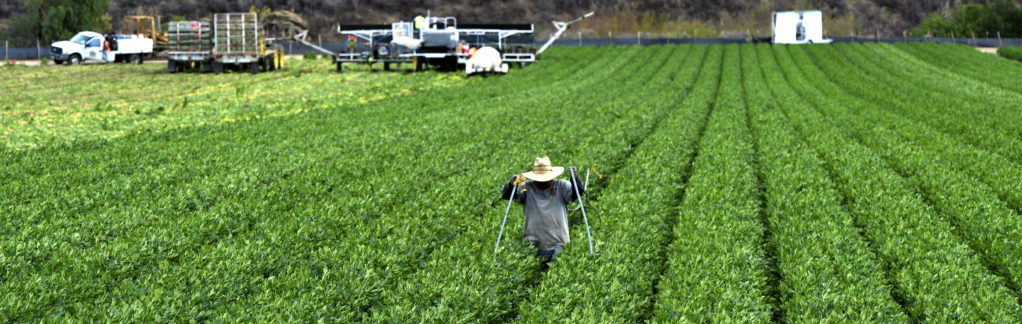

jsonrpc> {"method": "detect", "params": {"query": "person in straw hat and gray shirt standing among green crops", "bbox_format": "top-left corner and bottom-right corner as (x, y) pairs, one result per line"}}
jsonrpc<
(501, 156), (586, 269)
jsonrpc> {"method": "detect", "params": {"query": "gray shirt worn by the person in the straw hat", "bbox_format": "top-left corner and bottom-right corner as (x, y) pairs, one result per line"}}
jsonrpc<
(515, 179), (575, 249)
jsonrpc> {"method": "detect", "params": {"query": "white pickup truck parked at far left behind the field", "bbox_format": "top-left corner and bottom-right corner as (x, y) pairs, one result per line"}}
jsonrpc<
(50, 32), (153, 64)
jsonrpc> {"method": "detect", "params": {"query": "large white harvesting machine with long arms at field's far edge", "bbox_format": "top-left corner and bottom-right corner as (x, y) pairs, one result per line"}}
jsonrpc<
(295, 12), (593, 76)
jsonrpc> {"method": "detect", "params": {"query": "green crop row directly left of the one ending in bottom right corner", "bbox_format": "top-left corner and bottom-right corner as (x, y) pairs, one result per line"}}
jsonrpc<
(742, 46), (908, 323)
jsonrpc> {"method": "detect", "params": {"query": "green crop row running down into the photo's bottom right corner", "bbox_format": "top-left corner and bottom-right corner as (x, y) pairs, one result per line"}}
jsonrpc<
(760, 43), (1020, 322)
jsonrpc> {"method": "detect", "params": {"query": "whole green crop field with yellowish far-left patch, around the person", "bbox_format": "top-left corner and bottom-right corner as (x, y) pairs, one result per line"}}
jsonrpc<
(0, 44), (1022, 323)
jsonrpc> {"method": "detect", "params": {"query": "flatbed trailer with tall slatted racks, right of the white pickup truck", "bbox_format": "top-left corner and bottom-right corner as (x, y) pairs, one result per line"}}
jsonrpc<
(167, 12), (284, 74)
